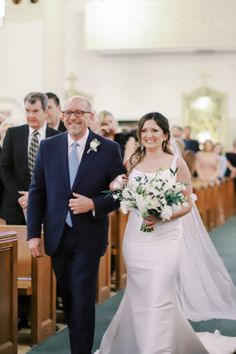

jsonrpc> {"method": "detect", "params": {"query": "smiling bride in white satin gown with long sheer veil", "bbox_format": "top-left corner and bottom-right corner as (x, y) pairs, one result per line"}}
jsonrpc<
(96, 113), (236, 354)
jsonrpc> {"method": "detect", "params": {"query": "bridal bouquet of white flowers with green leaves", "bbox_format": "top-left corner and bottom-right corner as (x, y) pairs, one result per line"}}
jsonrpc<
(110, 169), (187, 232)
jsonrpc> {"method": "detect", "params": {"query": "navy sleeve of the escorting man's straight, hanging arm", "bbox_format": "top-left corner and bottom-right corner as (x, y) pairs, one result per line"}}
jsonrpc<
(27, 144), (46, 240)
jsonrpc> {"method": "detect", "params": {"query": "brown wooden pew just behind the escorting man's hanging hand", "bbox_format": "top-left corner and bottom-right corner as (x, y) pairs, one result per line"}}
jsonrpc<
(0, 225), (56, 345)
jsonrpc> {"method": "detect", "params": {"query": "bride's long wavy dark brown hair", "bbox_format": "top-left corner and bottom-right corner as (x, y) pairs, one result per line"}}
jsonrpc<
(129, 112), (173, 170)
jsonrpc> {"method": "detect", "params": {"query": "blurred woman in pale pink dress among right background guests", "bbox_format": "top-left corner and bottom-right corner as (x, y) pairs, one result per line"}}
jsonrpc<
(196, 140), (220, 183)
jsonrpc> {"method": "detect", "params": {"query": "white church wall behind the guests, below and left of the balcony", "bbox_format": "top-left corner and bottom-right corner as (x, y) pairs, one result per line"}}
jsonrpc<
(0, 0), (236, 147)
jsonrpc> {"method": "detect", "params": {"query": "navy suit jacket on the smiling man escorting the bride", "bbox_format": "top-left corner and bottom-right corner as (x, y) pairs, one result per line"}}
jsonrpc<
(27, 131), (125, 257)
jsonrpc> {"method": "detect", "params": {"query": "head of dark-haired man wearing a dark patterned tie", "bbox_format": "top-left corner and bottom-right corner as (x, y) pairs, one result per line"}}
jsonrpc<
(24, 92), (48, 130)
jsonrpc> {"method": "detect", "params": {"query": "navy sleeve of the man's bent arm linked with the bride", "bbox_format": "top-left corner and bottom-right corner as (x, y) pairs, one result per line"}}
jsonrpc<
(93, 144), (126, 218)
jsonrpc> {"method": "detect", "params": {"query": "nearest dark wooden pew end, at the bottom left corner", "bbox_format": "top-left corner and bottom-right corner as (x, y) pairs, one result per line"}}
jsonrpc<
(0, 232), (17, 354)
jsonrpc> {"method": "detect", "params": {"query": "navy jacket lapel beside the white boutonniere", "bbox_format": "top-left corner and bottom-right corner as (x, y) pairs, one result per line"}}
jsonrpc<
(72, 130), (99, 190)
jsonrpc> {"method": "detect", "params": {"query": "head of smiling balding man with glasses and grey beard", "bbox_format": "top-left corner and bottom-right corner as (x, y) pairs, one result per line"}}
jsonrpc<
(62, 96), (92, 140)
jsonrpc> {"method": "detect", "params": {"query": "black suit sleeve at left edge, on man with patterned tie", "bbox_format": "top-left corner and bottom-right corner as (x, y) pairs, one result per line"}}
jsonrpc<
(0, 129), (18, 195)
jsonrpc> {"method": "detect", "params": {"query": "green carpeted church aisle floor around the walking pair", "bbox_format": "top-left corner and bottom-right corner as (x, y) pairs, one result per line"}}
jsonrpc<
(28, 217), (236, 354)
